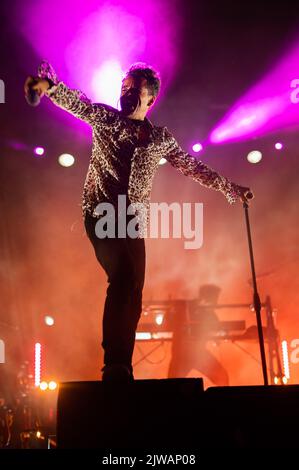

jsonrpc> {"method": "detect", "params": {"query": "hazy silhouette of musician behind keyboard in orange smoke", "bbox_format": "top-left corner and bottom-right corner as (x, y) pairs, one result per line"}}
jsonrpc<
(168, 284), (229, 386)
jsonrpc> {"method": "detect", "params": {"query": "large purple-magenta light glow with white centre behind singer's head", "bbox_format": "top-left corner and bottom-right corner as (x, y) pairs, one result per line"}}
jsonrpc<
(15, 0), (181, 106)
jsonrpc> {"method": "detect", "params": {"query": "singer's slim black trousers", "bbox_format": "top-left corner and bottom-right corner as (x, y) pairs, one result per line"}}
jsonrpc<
(85, 213), (145, 371)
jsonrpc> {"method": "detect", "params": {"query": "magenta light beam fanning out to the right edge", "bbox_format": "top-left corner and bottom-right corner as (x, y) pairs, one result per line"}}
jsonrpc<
(210, 43), (299, 144)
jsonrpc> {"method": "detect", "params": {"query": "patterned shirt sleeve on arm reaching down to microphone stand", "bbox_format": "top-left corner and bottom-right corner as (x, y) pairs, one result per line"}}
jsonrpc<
(164, 127), (240, 204)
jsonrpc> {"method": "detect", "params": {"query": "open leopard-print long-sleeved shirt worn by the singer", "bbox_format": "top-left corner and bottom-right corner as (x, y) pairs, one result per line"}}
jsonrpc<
(38, 61), (244, 237)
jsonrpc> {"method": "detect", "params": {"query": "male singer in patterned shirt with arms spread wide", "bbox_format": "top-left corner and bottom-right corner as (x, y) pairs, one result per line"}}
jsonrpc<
(25, 62), (252, 381)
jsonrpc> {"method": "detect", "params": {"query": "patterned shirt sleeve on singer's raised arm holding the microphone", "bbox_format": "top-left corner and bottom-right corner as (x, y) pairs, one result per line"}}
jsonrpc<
(38, 60), (106, 125)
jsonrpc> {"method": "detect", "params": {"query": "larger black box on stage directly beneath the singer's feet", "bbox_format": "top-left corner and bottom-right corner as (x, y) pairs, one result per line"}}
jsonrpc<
(57, 379), (204, 449)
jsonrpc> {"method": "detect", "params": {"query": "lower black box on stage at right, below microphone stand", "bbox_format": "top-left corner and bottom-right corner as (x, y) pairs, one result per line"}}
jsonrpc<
(203, 385), (299, 449)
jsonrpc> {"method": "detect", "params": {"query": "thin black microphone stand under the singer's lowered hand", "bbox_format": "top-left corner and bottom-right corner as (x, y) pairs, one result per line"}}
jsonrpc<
(243, 202), (268, 385)
